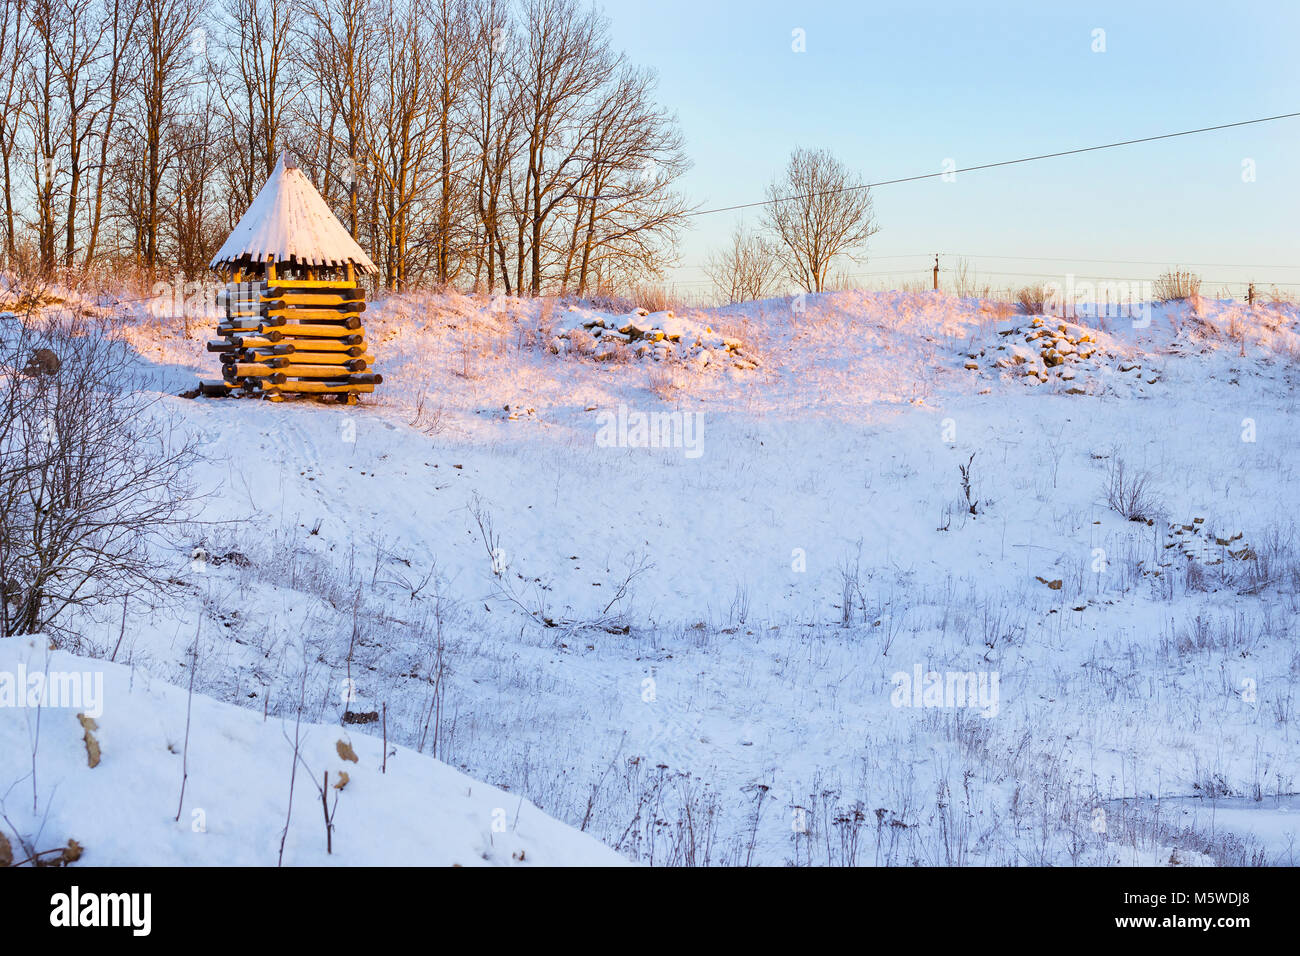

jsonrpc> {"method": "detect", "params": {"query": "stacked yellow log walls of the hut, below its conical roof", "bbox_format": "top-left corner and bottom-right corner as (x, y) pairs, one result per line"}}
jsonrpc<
(200, 277), (384, 405)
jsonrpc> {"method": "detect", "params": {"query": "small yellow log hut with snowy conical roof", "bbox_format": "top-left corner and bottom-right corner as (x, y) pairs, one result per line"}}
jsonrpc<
(200, 153), (384, 405)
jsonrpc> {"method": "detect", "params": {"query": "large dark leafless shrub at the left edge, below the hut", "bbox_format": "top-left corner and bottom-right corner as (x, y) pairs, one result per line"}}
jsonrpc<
(0, 319), (198, 635)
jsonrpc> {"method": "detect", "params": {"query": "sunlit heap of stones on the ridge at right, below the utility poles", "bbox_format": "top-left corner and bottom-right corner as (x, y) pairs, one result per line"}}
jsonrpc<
(965, 316), (1158, 394)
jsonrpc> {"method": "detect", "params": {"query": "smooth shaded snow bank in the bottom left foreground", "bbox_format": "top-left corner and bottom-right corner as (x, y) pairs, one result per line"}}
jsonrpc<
(0, 637), (621, 866)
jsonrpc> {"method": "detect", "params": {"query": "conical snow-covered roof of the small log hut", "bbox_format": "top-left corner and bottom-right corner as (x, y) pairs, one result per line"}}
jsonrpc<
(209, 153), (378, 272)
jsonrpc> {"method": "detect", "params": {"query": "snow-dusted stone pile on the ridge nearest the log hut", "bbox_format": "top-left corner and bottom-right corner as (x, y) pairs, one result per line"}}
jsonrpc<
(550, 306), (758, 369)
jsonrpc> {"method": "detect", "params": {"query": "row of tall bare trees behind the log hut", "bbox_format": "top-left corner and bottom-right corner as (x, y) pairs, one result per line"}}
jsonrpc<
(0, 0), (689, 295)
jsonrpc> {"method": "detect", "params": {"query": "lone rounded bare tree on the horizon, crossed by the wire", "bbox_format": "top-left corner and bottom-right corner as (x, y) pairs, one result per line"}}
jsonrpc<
(763, 150), (880, 293)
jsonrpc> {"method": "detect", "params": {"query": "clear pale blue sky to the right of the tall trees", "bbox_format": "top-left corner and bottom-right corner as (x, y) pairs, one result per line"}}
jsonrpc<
(597, 0), (1300, 294)
